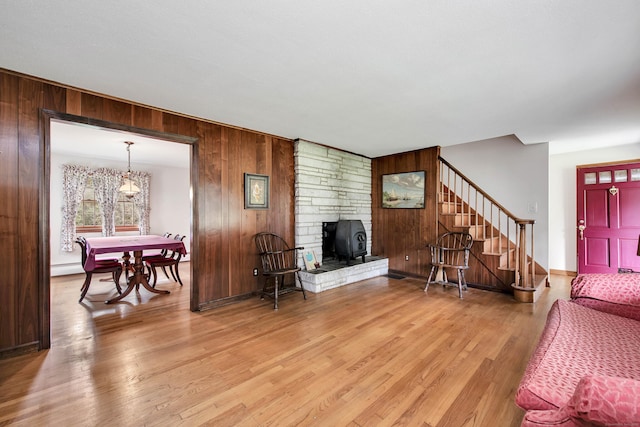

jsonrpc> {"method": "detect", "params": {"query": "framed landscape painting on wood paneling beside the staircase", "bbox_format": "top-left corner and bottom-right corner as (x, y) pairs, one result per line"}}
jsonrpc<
(382, 171), (426, 209)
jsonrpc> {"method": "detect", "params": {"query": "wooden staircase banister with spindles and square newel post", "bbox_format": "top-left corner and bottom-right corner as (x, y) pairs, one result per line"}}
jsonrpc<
(438, 157), (536, 291)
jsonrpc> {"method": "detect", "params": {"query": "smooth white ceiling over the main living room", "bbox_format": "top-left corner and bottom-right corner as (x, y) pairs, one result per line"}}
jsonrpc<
(0, 0), (640, 157)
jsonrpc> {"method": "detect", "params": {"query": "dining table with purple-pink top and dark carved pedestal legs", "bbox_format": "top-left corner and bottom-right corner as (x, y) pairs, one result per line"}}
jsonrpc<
(85, 235), (187, 304)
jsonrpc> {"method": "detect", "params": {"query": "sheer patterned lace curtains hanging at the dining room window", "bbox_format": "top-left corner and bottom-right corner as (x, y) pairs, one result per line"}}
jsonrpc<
(60, 165), (151, 252)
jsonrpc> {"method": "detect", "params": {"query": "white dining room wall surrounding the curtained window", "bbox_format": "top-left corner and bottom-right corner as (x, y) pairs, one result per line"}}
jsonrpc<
(50, 152), (191, 276)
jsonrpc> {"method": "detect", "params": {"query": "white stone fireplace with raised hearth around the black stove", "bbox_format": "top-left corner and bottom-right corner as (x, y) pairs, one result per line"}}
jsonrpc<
(294, 140), (388, 292)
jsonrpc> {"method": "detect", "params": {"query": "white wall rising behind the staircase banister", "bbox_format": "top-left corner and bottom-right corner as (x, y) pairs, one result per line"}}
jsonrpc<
(440, 136), (549, 269)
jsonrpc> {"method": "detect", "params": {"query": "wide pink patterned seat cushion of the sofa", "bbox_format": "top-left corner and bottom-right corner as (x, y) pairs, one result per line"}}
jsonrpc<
(516, 300), (640, 410)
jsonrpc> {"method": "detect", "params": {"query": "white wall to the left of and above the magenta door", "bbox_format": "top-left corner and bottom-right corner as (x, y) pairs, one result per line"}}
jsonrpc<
(549, 144), (640, 272)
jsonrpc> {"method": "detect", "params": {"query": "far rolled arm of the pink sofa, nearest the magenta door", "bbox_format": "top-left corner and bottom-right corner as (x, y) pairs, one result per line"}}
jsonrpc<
(571, 273), (640, 320)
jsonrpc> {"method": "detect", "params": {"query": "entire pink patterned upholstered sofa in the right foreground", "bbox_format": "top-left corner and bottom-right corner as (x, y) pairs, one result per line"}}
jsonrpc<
(515, 273), (640, 427)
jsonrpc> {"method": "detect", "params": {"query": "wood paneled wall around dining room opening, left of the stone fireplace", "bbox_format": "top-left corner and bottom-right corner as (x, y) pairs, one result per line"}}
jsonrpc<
(0, 70), (295, 356)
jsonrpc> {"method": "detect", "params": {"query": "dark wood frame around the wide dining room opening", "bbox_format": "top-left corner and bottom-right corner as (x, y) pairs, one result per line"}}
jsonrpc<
(38, 110), (199, 350)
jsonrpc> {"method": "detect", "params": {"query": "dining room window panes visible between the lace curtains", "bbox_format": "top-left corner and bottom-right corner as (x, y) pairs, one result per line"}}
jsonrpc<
(76, 176), (139, 233)
